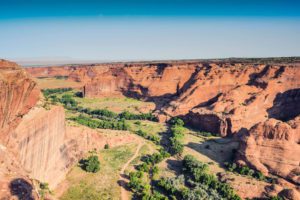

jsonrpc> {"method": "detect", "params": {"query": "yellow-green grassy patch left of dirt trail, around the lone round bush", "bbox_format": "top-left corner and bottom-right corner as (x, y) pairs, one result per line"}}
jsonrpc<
(60, 144), (136, 200)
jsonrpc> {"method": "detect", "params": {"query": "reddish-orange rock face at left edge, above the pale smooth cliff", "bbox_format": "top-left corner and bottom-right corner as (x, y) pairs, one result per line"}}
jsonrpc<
(0, 60), (40, 141)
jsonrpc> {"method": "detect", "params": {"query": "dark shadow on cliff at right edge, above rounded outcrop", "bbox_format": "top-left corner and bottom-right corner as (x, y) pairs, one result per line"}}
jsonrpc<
(267, 88), (300, 121)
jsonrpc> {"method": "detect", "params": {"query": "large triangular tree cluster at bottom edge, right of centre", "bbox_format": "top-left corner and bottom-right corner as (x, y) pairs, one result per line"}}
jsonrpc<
(182, 155), (241, 200)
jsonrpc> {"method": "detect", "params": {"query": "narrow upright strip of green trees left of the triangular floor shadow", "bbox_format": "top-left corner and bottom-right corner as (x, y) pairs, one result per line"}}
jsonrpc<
(169, 118), (184, 155)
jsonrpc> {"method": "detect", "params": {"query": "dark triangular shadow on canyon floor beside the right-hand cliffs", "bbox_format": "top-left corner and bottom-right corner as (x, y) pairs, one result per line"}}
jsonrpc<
(186, 138), (239, 167)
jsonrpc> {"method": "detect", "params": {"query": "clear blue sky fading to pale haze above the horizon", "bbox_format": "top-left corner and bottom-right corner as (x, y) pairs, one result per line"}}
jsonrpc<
(0, 0), (300, 60)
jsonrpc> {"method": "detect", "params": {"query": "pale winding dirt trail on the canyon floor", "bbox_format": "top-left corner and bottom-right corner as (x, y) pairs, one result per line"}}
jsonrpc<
(119, 141), (144, 200)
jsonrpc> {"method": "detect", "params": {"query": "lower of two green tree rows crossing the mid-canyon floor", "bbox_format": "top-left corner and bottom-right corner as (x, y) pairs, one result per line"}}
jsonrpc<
(71, 115), (129, 130)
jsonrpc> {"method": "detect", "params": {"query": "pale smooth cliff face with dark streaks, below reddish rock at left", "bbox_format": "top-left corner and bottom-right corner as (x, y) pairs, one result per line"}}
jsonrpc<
(7, 107), (69, 188)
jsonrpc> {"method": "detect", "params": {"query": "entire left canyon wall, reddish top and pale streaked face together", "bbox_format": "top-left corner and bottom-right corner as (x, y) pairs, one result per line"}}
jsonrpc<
(0, 60), (68, 199)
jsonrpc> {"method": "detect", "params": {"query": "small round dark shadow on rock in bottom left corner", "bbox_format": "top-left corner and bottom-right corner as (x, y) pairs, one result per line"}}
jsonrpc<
(9, 178), (34, 200)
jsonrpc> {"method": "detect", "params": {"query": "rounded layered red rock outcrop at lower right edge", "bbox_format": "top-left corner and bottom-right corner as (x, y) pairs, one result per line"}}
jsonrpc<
(237, 117), (300, 184)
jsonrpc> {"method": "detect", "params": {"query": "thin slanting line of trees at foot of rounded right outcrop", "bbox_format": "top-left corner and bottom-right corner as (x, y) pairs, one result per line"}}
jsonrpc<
(224, 162), (275, 182)
